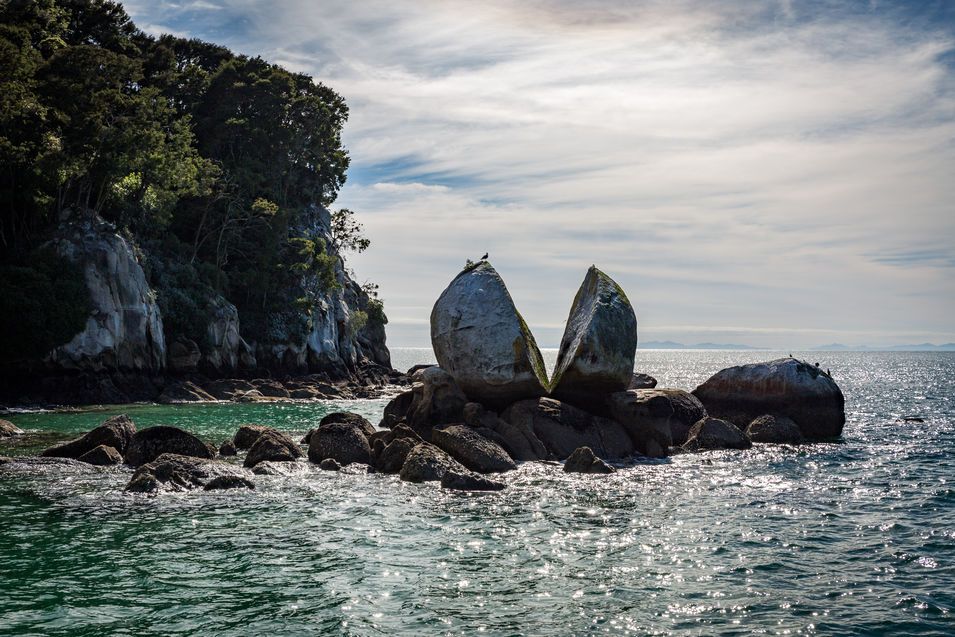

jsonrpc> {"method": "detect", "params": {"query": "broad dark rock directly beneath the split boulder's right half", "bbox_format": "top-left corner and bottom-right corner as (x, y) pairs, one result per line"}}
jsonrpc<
(501, 398), (634, 460)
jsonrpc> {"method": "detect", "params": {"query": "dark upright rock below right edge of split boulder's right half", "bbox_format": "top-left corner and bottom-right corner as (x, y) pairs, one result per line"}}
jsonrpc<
(607, 389), (673, 458)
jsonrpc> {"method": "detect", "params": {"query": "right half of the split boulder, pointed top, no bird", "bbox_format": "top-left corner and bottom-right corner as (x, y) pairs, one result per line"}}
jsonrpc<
(550, 266), (637, 408)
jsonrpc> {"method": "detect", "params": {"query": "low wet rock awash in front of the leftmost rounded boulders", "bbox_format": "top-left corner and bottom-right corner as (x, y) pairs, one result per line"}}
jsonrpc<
(126, 454), (254, 493)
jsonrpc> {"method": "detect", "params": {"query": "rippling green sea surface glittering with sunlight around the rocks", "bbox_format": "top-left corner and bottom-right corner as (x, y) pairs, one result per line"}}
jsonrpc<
(0, 350), (955, 636)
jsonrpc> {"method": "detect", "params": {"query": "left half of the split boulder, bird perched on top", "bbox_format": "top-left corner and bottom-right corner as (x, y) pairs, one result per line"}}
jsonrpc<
(431, 261), (548, 408)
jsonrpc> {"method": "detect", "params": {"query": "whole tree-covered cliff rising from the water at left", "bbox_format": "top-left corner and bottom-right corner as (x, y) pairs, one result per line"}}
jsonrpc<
(0, 0), (390, 398)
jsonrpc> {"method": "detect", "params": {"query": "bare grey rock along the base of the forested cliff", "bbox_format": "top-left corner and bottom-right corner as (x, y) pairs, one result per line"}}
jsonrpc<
(30, 207), (391, 388)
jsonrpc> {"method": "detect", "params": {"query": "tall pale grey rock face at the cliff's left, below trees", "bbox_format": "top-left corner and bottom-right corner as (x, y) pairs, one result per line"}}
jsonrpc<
(47, 216), (166, 372)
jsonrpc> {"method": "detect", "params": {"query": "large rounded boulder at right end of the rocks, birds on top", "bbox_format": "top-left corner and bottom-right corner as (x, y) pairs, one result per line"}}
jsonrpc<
(693, 358), (846, 440)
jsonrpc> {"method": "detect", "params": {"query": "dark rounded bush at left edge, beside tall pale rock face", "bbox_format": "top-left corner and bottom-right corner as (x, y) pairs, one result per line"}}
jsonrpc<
(0, 249), (91, 362)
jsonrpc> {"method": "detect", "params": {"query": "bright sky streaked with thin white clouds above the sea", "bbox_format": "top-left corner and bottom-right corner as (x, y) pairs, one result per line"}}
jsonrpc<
(125, 0), (955, 349)
